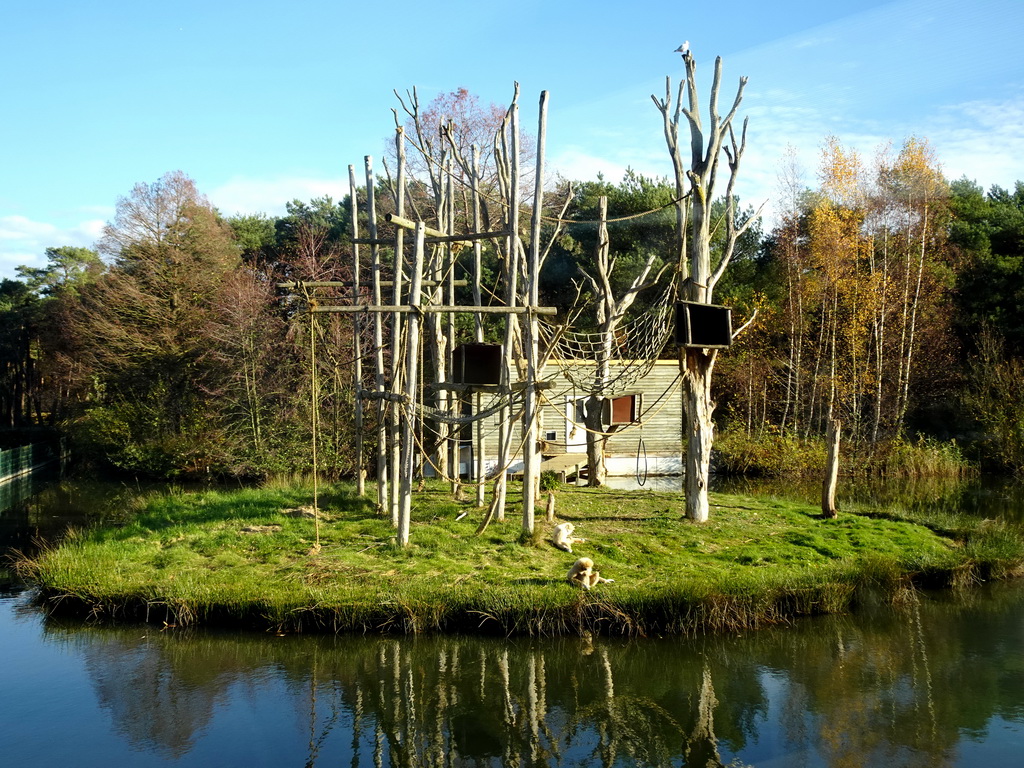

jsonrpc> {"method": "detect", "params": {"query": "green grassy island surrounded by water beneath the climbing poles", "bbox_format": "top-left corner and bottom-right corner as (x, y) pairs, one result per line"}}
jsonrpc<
(18, 484), (1024, 635)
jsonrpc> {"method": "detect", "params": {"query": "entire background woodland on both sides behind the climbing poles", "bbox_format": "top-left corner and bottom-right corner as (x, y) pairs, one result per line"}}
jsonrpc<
(0, 116), (1024, 477)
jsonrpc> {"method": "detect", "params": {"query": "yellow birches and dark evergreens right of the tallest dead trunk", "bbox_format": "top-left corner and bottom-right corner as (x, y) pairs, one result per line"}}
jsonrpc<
(723, 138), (1024, 471)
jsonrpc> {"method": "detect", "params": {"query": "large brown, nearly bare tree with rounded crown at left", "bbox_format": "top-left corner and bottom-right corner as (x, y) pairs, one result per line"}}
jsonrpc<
(69, 172), (240, 473)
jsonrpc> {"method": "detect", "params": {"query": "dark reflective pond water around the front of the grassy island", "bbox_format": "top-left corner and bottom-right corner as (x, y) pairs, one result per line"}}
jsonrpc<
(0, 473), (1024, 768)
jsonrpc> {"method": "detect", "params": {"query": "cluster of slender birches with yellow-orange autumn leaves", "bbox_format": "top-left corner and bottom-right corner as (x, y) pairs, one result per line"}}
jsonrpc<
(757, 138), (952, 442)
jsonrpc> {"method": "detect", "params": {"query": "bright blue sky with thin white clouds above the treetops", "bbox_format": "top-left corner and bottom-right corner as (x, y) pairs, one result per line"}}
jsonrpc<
(0, 0), (1024, 278)
